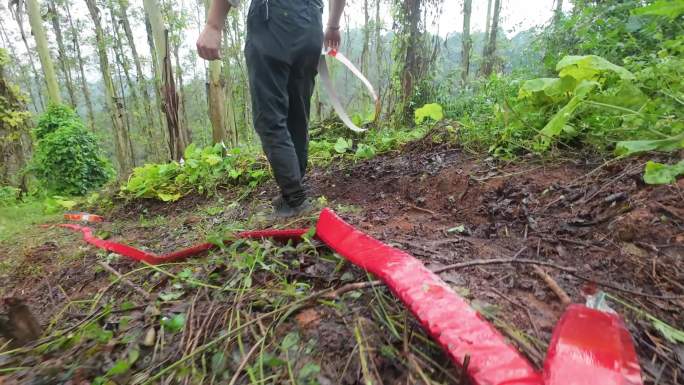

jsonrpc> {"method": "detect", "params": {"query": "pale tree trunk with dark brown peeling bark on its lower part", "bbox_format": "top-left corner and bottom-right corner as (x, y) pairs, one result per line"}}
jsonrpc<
(143, 0), (190, 160)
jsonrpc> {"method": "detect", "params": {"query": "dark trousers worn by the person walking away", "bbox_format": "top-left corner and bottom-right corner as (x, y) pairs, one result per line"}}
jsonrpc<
(245, 0), (323, 206)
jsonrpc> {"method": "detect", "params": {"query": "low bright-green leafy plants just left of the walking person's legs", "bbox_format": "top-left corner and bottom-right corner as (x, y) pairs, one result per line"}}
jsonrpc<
(121, 144), (268, 202)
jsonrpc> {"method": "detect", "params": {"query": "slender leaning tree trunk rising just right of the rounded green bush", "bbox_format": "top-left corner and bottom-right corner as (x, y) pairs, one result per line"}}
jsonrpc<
(85, 0), (133, 174)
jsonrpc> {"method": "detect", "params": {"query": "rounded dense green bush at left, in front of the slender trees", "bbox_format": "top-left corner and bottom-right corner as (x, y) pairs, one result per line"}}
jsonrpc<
(31, 105), (113, 195)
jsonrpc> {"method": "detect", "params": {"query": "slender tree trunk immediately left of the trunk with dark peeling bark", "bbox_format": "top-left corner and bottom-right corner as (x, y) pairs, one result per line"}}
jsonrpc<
(119, 0), (162, 161)
